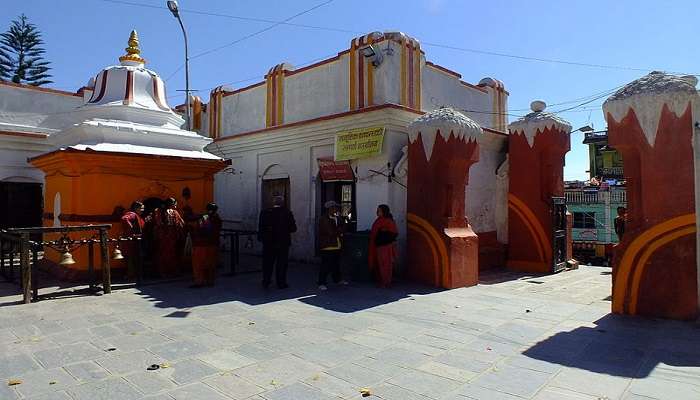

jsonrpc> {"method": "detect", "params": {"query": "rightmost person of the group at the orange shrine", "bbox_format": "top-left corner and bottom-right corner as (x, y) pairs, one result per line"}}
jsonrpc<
(191, 203), (222, 288)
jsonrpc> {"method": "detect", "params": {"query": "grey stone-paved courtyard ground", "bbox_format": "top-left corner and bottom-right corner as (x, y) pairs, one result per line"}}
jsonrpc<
(0, 266), (700, 400)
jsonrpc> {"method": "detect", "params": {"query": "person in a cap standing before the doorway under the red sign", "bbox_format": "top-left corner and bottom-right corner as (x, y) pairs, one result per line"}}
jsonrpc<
(318, 201), (348, 291)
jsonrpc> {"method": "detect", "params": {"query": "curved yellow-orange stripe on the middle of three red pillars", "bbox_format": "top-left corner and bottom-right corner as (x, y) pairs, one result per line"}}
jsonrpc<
(508, 193), (552, 269)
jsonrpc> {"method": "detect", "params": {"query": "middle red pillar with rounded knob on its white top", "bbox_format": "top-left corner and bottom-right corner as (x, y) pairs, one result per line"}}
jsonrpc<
(506, 101), (571, 273)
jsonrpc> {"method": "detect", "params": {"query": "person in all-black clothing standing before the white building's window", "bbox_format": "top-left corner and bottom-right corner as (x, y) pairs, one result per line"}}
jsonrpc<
(258, 196), (297, 289)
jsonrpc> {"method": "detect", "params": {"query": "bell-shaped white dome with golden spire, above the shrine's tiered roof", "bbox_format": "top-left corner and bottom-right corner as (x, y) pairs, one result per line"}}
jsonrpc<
(78, 31), (184, 127)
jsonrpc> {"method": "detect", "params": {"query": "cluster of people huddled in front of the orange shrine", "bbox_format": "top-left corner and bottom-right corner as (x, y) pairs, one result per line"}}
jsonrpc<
(121, 197), (222, 288)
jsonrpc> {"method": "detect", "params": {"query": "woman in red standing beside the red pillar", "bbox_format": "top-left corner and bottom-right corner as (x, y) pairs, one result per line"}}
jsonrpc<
(369, 204), (399, 288)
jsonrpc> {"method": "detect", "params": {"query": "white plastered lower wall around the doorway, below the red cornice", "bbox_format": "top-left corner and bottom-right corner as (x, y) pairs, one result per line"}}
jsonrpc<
(208, 110), (415, 261)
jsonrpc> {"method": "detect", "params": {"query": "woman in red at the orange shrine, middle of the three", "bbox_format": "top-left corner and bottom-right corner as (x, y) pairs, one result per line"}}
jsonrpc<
(153, 197), (185, 277)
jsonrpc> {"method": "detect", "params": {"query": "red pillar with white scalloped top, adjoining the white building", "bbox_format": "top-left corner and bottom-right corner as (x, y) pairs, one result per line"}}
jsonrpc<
(407, 108), (483, 289)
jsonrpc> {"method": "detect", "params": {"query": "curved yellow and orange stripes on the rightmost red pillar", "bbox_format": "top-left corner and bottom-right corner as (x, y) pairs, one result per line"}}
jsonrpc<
(612, 213), (697, 315)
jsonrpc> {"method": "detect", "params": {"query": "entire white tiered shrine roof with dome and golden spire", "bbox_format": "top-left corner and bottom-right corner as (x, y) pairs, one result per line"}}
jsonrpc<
(50, 31), (219, 160)
